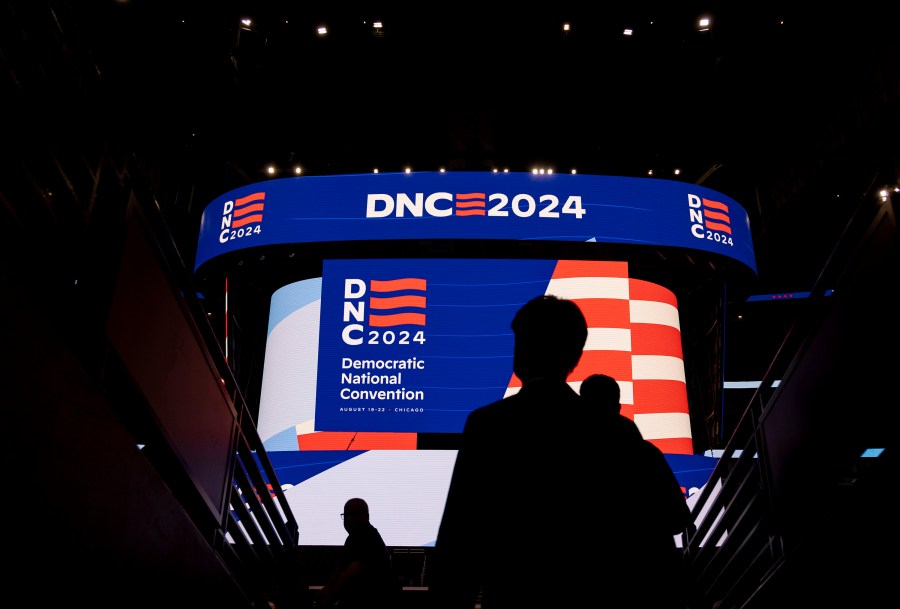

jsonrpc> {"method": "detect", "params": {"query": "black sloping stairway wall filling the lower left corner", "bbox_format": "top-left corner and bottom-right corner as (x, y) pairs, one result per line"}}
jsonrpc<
(0, 267), (249, 609)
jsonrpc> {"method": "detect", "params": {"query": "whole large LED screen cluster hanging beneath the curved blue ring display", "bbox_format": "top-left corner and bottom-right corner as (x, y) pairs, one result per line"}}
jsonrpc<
(257, 258), (714, 547)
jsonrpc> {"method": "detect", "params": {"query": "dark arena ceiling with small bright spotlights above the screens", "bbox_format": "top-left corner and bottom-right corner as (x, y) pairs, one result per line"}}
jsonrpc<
(0, 0), (900, 432)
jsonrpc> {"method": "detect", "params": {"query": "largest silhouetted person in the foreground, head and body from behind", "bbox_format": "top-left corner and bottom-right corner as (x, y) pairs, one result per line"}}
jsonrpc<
(429, 296), (687, 609)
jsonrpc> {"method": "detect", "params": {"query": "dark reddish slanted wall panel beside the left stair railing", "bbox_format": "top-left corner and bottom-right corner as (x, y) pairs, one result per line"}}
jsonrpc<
(106, 202), (237, 523)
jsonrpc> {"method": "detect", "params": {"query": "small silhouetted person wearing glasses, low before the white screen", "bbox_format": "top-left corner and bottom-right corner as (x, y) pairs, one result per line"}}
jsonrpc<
(315, 497), (400, 609)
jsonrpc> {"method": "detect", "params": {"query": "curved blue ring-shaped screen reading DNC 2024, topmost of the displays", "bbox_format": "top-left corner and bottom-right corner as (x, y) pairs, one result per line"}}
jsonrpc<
(194, 171), (756, 273)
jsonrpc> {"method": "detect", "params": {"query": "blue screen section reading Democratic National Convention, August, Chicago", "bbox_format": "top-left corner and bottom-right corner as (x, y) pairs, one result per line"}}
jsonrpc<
(315, 259), (556, 433)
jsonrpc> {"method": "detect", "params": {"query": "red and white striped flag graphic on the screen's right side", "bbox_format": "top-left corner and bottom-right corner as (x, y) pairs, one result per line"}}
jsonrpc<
(507, 260), (693, 454)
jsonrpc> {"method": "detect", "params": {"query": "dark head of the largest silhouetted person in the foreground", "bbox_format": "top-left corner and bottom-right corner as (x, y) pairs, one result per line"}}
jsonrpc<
(512, 296), (587, 382)
